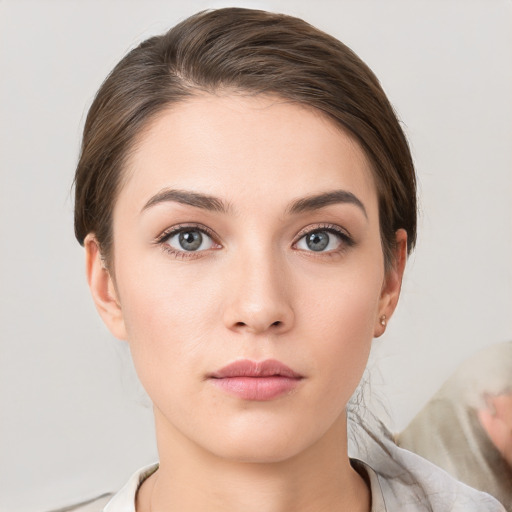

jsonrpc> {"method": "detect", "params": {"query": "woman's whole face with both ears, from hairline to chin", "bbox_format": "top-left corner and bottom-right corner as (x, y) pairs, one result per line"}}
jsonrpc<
(86, 95), (405, 461)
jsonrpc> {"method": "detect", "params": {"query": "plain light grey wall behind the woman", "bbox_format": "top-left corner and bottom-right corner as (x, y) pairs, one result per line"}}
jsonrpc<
(0, 0), (512, 512)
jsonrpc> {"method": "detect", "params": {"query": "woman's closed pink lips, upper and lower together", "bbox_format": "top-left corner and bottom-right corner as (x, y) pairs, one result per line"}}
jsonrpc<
(209, 359), (303, 401)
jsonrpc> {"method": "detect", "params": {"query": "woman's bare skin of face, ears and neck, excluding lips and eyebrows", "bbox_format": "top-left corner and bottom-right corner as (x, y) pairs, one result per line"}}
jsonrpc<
(85, 94), (406, 512)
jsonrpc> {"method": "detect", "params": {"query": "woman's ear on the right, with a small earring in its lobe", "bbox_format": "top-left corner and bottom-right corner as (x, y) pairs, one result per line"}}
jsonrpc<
(374, 229), (407, 338)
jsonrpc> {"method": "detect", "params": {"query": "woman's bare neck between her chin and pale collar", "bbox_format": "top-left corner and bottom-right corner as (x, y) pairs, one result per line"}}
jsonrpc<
(137, 411), (370, 512)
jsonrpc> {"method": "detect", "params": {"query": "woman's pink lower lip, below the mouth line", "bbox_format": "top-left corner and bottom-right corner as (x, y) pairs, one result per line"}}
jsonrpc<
(211, 375), (301, 401)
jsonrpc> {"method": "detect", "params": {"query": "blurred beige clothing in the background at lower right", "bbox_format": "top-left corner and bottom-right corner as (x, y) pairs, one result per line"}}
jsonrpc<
(395, 342), (512, 512)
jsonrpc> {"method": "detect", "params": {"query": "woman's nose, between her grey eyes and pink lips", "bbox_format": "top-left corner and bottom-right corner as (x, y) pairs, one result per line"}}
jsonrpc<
(224, 251), (294, 334)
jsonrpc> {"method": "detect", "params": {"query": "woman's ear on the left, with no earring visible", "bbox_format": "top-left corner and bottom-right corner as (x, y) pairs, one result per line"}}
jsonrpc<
(84, 233), (126, 340)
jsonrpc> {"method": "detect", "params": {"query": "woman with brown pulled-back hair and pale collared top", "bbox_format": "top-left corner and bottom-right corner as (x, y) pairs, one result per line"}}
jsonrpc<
(71, 9), (502, 512)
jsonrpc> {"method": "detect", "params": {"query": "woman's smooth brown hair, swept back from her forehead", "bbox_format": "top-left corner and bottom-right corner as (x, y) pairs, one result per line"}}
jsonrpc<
(75, 8), (416, 264)
